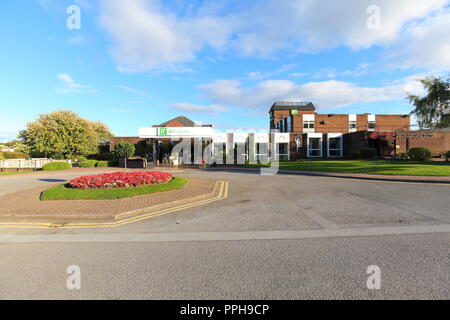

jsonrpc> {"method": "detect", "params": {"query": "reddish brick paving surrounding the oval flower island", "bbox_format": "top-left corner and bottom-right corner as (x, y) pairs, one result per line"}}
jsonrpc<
(0, 178), (216, 219)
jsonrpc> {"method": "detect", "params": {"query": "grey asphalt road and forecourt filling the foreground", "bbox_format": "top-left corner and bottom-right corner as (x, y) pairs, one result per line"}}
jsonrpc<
(0, 171), (450, 299)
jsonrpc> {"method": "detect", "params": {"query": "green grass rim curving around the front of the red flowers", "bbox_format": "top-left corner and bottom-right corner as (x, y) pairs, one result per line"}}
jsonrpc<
(41, 177), (189, 200)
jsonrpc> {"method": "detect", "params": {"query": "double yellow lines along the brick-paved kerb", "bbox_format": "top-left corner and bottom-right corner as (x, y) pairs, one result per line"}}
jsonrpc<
(0, 181), (228, 229)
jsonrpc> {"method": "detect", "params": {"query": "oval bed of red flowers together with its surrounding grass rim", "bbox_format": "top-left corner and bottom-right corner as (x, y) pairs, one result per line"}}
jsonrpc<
(41, 171), (189, 200)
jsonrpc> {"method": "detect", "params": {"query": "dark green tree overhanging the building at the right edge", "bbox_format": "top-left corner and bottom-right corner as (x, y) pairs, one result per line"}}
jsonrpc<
(407, 77), (450, 129)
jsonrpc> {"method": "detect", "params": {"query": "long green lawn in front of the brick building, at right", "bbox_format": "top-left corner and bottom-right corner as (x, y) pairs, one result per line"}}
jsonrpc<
(245, 160), (450, 176)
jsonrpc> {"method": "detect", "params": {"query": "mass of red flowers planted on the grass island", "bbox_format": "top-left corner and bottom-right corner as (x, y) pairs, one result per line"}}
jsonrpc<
(69, 171), (173, 189)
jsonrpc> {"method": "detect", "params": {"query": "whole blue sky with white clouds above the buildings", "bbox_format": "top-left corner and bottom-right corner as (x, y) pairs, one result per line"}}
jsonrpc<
(0, 0), (450, 141)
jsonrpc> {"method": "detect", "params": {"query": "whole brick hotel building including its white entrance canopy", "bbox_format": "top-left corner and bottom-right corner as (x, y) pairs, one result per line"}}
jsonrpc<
(109, 102), (450, 165)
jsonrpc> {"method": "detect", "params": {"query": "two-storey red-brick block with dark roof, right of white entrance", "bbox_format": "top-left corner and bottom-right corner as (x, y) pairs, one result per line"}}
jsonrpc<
(269, 102), (410, 159)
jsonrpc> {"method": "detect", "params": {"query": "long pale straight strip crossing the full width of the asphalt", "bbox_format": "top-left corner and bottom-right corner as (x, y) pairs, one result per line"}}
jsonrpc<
(0, 224), (450, 243)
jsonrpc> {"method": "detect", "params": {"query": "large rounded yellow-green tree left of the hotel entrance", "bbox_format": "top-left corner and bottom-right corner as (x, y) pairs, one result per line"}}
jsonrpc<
(18, 111), (109, 159)
